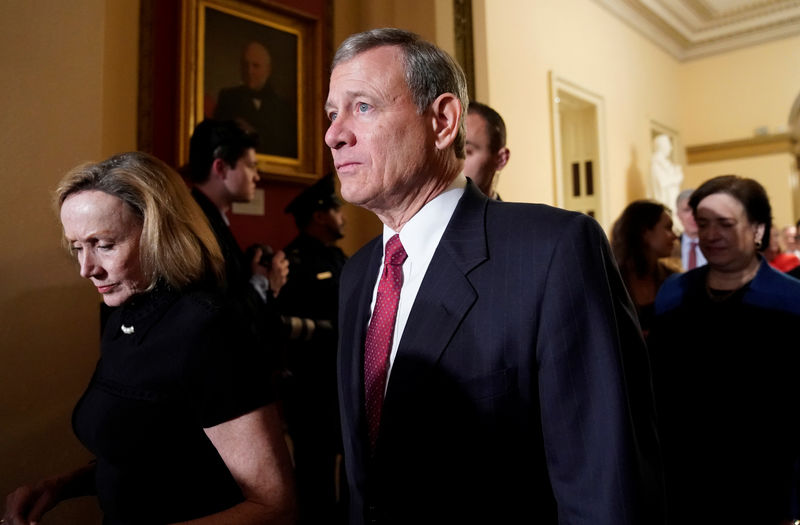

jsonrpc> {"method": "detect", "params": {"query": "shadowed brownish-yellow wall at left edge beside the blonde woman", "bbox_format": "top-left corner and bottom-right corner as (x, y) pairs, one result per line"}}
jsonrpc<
(0, 0), (138, 524)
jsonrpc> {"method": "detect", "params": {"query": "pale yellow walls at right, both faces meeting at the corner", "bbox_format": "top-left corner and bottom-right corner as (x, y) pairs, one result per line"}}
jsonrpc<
(473, 0), (800, 228)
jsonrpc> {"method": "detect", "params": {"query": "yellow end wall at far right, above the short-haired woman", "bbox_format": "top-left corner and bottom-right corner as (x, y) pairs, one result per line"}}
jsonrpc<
(678, 33), (800, 226)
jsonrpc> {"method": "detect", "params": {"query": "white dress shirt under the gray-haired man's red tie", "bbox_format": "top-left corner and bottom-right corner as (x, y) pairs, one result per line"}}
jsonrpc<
(370, 175), (467, 386)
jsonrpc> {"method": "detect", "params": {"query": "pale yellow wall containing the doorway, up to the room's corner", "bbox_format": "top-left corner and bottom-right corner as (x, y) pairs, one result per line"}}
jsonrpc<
(477, 0), (679, 227)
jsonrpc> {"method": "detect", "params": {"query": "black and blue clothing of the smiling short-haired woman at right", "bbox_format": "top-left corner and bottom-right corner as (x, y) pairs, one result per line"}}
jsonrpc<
(648, 262), (800, 524)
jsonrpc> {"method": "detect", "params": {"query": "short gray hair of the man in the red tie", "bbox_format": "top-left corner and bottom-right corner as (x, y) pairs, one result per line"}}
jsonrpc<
(331, 27), (469, 159)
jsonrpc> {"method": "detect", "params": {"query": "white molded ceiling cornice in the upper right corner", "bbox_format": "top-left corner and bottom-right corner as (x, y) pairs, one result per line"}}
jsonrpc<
(595, 0), (800, 61)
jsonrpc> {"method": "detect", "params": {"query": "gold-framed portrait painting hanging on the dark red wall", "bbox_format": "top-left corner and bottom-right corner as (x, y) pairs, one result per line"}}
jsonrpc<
(179, 0), (322, 180)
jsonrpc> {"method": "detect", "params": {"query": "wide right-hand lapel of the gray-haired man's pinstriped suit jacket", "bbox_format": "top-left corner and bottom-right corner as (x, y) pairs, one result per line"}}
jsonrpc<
(376, 182), (488, 408)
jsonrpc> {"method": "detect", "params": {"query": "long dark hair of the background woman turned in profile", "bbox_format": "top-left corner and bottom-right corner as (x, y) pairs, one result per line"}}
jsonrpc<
(611, 200), (669, 277)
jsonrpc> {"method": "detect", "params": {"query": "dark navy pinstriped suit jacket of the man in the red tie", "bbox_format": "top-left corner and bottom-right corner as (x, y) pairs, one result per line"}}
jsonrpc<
(339, 183), (660, 525)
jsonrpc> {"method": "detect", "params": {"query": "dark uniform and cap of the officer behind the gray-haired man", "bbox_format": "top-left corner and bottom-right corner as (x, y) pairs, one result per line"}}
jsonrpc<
(279, 176), (347, 524)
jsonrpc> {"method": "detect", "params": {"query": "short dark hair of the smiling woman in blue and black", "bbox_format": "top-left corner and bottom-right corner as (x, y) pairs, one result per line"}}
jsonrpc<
(689, 175), (772, 251)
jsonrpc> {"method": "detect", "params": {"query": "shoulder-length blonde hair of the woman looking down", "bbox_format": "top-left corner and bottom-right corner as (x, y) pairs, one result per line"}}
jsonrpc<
(55, 152), (225, 290)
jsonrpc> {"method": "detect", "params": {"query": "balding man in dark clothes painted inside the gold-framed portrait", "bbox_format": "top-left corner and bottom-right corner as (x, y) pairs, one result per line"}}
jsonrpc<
(214, 41), (298, 158)
